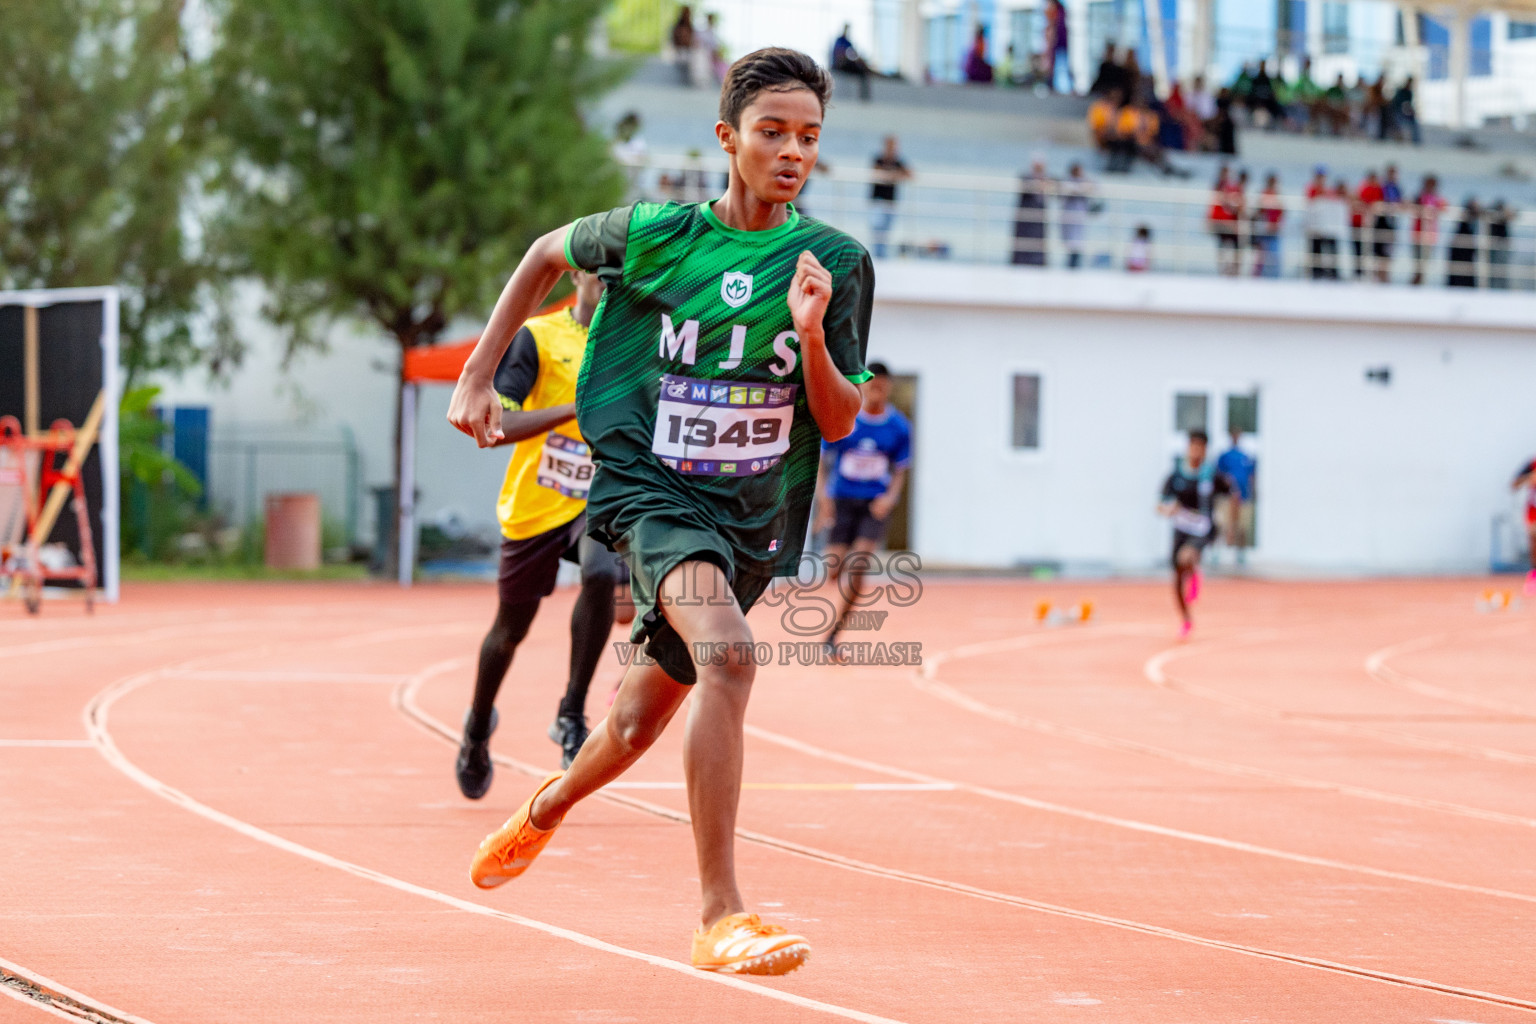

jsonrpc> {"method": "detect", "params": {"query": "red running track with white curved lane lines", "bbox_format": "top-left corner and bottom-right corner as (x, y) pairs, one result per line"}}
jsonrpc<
(0, 579), (1536, 1024)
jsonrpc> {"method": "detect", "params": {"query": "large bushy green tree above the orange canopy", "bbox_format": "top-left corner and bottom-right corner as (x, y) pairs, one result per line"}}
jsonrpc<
(214, 0), (624, 568)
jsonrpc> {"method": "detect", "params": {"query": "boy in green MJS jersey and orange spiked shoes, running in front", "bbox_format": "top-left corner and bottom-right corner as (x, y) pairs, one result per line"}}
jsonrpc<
(449, 49), (874, 975)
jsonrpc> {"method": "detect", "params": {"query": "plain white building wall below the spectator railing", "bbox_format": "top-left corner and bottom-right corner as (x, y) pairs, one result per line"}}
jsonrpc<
(871, 264), (1536, 573)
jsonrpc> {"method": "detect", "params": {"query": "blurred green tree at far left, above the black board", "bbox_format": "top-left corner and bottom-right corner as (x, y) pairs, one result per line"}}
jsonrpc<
(0, 0), (238, 382)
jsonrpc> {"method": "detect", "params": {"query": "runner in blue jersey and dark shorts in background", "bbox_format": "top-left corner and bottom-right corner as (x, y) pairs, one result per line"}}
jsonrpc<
(816, 362), (912, 645)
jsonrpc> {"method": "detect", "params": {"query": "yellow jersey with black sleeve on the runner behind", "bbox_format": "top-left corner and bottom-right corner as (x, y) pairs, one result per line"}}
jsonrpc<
(496, 309), (593, 540)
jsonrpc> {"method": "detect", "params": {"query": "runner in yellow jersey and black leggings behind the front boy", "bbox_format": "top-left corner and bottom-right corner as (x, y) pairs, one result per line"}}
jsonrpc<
(456, 272), (633, 800)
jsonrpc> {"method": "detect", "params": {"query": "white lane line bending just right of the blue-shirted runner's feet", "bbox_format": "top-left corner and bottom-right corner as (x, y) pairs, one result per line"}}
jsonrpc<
(912, 633), (1536, 827)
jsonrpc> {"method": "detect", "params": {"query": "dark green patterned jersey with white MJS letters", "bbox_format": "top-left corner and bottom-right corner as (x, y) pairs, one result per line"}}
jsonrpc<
(565, 203), (874, 574)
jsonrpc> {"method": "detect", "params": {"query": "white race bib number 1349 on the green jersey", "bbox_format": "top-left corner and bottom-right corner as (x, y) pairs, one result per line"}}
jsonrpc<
(651, 373), (799, 476)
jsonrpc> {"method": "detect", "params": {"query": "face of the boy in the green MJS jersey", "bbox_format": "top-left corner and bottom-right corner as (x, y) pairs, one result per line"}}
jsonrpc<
(717, 88), (822, 203)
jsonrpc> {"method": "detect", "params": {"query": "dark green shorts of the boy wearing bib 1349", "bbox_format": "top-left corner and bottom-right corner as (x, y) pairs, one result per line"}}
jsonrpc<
(617, 508), (773, 686)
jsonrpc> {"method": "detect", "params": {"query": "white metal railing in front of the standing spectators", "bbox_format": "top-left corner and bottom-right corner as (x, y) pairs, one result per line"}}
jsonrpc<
(630, 155), (1536, 292)
